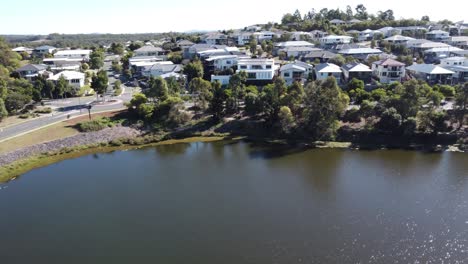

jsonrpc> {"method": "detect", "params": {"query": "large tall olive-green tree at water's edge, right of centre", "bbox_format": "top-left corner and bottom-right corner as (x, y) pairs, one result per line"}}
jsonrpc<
(304, 77), (349, 139)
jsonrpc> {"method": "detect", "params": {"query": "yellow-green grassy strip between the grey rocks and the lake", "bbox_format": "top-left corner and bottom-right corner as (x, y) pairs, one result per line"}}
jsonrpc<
(0, 137), (225, 183)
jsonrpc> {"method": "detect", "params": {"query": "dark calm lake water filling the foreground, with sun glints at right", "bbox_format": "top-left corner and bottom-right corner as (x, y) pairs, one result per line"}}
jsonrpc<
(0, 142), (468, 264)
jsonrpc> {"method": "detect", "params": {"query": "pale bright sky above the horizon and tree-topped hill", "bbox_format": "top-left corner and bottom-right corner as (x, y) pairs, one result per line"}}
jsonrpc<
(0, 0), (468, 34)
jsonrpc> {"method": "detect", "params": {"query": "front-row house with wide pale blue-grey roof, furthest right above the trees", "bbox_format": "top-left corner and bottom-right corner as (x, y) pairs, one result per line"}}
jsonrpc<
(406, 64), (455, 84)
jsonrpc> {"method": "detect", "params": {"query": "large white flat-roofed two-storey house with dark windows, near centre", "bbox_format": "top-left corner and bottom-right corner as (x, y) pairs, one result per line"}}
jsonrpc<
(237, 59), (277, 81)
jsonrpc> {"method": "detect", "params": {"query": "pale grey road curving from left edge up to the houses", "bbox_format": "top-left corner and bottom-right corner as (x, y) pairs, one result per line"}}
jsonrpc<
(0, 56), (134, 142)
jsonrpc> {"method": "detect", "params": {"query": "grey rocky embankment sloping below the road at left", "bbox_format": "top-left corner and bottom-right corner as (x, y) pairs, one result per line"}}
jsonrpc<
(0, 126), (141, 167)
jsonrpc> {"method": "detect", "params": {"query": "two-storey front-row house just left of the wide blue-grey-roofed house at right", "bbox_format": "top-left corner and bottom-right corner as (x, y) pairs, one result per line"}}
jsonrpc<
(372, 59), (406, 83)
